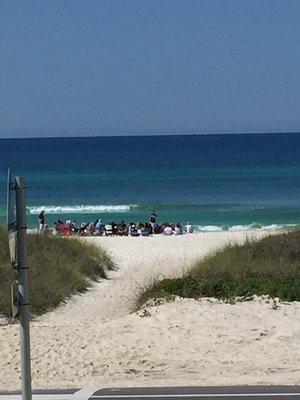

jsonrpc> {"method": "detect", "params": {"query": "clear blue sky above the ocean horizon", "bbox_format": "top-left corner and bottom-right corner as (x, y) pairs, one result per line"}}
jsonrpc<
(0, 0), (300, 137)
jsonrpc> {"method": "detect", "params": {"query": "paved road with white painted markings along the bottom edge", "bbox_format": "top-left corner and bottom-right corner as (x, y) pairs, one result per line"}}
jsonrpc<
(0, 386), (300, 400)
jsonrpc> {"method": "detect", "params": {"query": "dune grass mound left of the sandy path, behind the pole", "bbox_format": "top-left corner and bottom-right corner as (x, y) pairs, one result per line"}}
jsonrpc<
(0, 229), (114, 316)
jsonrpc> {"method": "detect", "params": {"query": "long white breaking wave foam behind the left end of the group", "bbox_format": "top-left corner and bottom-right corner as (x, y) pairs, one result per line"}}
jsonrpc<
(27, 204), (135, 215)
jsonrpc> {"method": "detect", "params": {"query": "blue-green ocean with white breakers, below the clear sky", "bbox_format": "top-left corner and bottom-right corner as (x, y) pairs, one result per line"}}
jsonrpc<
(0, 133), (300, 231)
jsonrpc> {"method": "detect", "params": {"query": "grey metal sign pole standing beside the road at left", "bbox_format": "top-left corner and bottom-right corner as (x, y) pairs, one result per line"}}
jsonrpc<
(15, 177), (32, 400)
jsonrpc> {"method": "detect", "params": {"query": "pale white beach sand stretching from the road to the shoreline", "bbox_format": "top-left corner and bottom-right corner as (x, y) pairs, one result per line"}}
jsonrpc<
(0, 231), (300, 389)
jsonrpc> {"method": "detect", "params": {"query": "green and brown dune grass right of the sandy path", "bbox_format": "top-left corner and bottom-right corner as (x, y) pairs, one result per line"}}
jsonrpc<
(136, 231), (300, 308)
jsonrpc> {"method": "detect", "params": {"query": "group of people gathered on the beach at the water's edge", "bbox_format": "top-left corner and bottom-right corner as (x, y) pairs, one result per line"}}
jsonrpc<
(38, 211), (194, 236)
